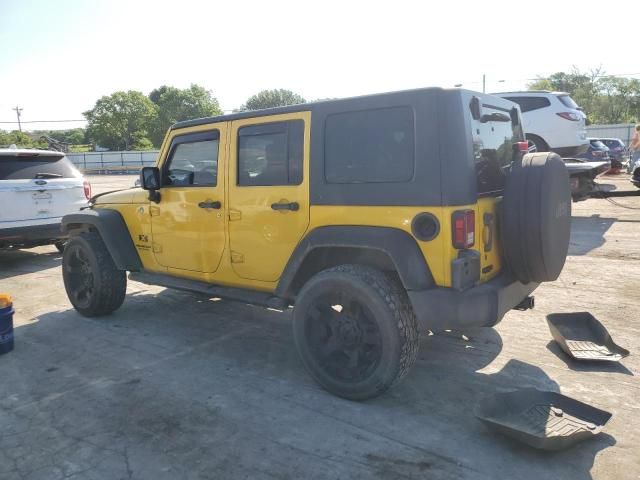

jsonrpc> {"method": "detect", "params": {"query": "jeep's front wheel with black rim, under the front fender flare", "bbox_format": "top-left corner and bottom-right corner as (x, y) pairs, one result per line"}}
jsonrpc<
(62, 232), (127, 317)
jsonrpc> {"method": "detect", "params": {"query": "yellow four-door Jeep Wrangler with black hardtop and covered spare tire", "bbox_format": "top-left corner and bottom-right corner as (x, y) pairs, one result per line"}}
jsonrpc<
(63, 88), (571, 400)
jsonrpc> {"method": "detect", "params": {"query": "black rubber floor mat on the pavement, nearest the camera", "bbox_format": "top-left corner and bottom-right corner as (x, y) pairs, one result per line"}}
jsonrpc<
(476, 388), (611, 450)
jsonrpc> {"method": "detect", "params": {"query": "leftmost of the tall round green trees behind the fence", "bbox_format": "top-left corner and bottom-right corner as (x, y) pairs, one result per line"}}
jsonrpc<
(83, 90), (157, 150)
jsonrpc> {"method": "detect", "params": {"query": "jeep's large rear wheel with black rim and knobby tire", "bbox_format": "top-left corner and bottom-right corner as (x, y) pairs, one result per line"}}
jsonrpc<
(293, 265), (419, 400)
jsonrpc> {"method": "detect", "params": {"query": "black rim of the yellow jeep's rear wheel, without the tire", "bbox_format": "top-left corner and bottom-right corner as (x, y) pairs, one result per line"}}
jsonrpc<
(305, 296), (382, 383)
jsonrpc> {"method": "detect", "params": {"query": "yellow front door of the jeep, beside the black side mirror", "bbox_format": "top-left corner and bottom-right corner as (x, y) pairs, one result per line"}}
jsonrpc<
(149, 123), (228, 273)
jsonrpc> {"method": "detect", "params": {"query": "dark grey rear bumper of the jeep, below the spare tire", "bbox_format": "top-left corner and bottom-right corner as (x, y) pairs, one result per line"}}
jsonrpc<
(408, 274), (539, 331)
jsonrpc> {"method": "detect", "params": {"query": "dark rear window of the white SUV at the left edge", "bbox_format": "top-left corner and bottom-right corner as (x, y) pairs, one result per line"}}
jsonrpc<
(0, 155), (81, 180)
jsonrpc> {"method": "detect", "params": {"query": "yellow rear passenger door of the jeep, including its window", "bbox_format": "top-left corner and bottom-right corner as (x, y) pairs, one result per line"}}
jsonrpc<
(229, 112), (311, 282)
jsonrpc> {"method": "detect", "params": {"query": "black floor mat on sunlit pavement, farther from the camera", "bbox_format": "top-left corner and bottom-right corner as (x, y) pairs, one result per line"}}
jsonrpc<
(547, 312), (629, 362)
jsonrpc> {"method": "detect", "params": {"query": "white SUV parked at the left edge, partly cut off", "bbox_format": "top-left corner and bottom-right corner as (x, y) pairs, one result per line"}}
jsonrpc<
(0, 148), (91, 251)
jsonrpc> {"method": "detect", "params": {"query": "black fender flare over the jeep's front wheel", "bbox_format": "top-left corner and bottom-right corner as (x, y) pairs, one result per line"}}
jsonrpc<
(61, 208), (142, 271)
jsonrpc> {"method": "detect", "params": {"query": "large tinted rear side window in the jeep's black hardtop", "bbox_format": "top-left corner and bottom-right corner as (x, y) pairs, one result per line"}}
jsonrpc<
(324, 107), (415, 183)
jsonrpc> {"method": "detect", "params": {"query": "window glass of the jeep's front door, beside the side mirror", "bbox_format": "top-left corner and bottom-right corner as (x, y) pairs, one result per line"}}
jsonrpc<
(163, 131), (220, 187)
